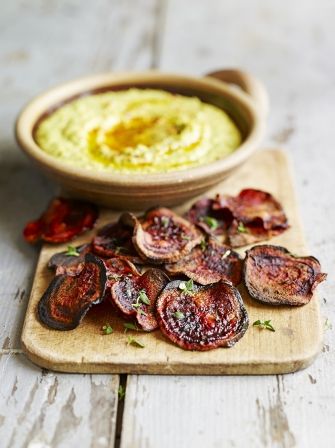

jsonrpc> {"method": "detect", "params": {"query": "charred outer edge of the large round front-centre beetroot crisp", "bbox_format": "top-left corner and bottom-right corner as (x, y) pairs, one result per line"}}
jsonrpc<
(156, 280), (249, 351)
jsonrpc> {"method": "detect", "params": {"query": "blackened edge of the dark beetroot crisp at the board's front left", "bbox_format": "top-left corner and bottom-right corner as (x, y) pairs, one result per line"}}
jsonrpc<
(37, 253), (107, 330)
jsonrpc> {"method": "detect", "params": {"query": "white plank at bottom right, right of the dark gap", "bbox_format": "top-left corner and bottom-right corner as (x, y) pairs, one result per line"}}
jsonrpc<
(121, 362), (335, 448)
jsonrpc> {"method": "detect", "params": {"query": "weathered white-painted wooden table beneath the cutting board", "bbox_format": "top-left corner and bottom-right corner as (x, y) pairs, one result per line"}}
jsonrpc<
(0, 0), (335, 448)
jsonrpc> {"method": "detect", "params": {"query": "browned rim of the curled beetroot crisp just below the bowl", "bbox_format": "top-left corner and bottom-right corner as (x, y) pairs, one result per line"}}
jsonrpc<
(133, 207), (203, 264)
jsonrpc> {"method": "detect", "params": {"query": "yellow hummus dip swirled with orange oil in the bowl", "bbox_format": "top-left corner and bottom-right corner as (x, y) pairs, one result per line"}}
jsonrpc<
(35, 88), (241, 173)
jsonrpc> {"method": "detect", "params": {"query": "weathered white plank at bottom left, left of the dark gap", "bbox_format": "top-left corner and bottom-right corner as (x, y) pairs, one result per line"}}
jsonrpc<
(0, 354), (119, 448)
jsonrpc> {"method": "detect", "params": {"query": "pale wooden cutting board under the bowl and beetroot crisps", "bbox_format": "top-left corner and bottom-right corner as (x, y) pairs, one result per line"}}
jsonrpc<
(22, 150), (322, 375)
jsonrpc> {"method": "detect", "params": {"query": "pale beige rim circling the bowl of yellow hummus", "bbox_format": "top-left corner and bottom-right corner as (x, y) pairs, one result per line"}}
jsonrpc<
(15, 70), (265, 187)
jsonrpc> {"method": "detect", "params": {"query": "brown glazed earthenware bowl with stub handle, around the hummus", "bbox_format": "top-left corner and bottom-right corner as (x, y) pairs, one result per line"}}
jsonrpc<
(16, 70), (268, 210)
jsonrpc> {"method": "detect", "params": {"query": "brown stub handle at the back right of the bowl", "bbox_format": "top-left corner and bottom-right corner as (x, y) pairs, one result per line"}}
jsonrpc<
(206, 69), (269, 117)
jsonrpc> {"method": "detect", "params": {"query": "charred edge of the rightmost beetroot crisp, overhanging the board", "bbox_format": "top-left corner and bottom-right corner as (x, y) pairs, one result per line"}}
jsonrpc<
(243, 244), (327, 306)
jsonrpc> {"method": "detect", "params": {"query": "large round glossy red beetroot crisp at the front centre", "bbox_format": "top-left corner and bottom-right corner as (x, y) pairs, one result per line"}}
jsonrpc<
(157, 280), (248, 351)
